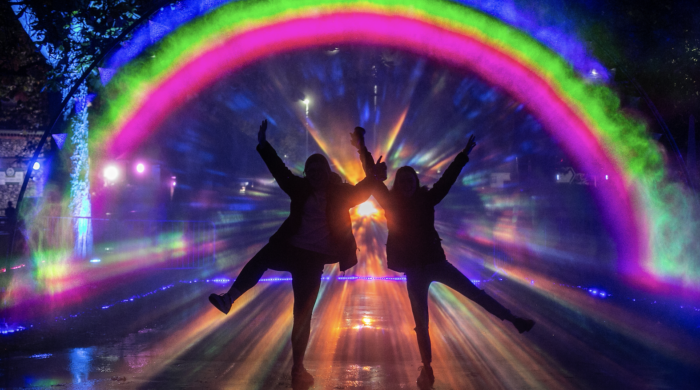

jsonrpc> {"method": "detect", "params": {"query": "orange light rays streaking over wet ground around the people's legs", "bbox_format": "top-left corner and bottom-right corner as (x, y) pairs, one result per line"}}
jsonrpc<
(117, 281), (592, 389)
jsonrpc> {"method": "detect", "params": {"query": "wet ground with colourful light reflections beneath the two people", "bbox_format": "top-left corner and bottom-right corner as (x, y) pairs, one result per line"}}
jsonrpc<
(0, 280), (700, 389)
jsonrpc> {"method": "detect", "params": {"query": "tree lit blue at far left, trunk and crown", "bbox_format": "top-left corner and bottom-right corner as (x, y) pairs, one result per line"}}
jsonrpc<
(10, 0), (148, 256)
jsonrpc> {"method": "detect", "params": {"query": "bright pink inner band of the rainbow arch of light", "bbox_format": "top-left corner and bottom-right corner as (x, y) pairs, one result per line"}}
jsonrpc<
(110, 12), (649, 277)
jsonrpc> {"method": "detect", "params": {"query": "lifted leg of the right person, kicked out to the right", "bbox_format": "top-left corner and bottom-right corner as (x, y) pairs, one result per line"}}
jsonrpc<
(427, 261), (535, 333)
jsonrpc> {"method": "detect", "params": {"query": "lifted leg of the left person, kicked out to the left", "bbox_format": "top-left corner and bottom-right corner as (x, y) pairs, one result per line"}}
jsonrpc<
(209, 244), (279, 314)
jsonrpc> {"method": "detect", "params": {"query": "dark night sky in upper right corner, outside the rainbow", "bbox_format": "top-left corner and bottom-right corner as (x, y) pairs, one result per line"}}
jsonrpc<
(572, 0), (700, 154)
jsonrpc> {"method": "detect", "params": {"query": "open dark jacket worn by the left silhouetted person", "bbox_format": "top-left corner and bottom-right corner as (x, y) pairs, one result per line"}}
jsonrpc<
(256, 142), (376, 271)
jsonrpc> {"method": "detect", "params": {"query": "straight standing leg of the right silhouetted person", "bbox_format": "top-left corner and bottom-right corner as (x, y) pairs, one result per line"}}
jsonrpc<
(406, 269), (435, 388)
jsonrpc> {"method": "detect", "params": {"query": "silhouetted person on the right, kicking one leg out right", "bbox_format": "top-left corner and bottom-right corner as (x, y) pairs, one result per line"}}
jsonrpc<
(360, 135), (535, 388)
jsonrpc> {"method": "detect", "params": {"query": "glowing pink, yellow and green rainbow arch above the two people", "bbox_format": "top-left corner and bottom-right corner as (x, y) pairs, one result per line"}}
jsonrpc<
(91, 0), (698, 292)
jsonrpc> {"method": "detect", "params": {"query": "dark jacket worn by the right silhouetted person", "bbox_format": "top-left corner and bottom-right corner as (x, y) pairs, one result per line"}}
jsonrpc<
(373, 152), (469, 272)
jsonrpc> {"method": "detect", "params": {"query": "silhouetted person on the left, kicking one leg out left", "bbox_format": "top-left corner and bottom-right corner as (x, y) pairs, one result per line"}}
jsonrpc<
(209, 120), (376, 387)
